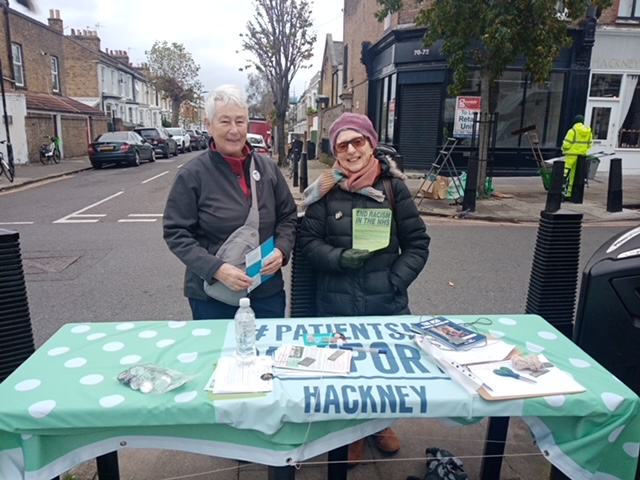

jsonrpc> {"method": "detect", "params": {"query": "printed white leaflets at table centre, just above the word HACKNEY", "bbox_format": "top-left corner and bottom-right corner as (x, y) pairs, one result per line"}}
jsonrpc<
(273, 344), (352, 376)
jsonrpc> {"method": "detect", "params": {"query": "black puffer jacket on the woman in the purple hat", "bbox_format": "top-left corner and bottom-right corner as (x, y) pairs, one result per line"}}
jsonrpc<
(298, 154), (430, 316)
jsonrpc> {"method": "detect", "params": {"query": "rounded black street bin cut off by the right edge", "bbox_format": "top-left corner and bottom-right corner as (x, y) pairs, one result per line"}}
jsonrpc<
(573, 227), (640, 394)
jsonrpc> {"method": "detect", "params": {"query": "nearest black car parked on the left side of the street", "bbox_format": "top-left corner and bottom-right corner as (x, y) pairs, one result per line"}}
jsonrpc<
(89, 132), (156, 170)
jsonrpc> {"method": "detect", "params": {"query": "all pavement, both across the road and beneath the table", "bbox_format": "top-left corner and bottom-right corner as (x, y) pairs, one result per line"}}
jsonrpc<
(0, 157), (640, 480)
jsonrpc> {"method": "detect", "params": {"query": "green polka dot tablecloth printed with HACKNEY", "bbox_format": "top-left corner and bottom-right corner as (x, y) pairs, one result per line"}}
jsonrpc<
(0, 315), (640, 480)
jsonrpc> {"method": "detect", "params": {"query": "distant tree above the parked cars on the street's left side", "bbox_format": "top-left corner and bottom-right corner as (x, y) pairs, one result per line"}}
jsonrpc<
(146, 40), (202, 125)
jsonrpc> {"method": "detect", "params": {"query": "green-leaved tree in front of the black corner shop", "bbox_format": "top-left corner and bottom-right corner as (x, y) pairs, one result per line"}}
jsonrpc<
(376, 0), (611, 196)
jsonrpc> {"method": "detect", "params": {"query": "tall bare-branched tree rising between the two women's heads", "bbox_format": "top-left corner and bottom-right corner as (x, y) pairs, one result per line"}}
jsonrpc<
(240, 0), (316, 164)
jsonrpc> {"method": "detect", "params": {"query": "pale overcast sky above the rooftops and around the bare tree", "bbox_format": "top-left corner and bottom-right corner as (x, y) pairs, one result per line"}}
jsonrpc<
(16, 0), (344, 96)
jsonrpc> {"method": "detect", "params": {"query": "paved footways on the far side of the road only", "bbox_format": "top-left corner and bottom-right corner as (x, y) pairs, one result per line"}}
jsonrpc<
(0, 157), (640, 227)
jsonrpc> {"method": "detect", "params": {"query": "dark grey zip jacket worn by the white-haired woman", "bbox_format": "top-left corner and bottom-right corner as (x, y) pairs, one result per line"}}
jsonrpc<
(163, 150), (297, 300)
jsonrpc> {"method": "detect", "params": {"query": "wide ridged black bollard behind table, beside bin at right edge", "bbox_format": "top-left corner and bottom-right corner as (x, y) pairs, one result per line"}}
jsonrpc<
(525, 209), (582, 338)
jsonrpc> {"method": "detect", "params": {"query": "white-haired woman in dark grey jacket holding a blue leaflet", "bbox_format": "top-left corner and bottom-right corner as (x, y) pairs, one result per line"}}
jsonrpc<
(163, 85), (297, 319)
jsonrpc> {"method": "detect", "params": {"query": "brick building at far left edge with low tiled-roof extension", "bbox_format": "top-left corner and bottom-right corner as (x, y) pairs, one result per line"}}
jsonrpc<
(0, 6), (107, 163)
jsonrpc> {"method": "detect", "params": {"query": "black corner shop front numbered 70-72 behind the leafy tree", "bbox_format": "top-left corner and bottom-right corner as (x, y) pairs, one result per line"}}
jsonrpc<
(362, 19), (595, 176)
